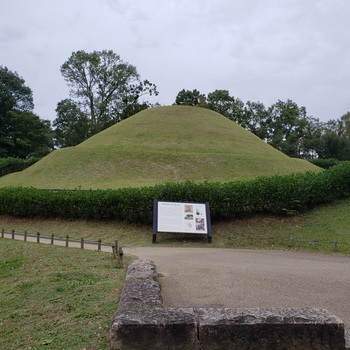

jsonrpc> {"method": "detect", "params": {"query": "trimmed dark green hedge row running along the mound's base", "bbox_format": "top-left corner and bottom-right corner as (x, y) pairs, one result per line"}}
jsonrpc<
(0, 162), (350, 224)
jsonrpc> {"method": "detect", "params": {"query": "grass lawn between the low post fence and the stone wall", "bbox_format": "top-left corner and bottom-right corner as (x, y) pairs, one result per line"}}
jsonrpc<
(0, 239), (130, 350)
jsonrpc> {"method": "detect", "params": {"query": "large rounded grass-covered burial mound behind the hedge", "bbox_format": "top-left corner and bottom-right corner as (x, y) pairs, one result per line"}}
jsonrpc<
(0, 106), (319, 189)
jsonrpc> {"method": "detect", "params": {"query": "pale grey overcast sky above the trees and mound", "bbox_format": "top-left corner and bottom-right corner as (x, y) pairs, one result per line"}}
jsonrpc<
(0, 0), (350, 121)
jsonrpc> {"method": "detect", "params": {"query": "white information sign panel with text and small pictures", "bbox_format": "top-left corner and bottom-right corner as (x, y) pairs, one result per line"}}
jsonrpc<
(157, 202), (208, 234)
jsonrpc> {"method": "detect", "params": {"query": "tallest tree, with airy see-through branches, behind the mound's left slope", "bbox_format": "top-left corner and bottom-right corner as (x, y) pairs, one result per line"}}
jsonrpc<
(61, 50), (158, 134)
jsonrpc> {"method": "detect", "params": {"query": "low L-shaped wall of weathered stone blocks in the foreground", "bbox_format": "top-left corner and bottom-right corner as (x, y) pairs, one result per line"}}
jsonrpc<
(109, 259), (346, 350)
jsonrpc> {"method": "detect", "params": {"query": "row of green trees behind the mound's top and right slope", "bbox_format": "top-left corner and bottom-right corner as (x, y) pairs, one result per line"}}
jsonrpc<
(175, 89), (350, 160)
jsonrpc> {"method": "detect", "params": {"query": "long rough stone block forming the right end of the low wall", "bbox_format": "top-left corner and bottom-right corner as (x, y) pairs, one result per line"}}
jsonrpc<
(196, 308), (345, 350)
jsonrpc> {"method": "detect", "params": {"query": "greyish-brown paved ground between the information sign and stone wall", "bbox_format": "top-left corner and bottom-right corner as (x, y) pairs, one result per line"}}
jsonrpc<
(124, 247), (350, 328)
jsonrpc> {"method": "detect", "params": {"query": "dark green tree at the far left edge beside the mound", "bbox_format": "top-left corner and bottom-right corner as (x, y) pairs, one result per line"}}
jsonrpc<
(0, 66), (53, 158)
